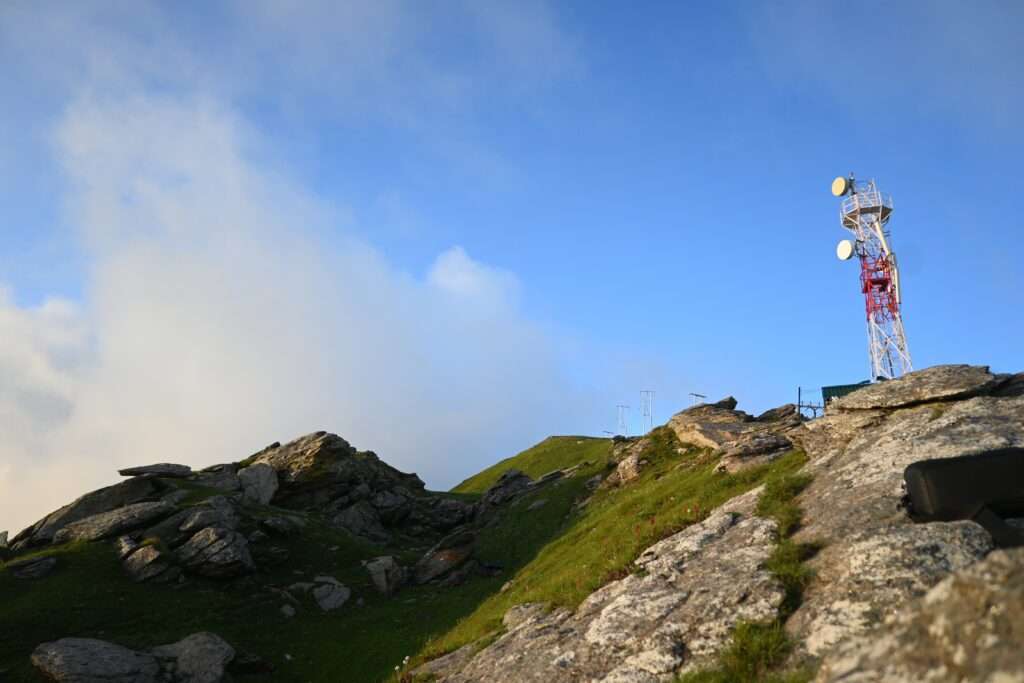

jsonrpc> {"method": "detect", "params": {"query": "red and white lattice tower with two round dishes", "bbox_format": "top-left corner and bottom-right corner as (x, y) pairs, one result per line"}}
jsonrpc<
(833, 174), (913, 381)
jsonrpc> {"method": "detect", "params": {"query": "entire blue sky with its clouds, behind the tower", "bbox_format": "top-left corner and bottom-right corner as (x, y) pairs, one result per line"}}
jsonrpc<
(0, 1), (1024, 527)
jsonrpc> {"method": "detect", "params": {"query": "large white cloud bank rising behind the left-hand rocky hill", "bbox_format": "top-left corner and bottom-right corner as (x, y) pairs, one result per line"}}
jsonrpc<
(0, 96), (567, 529)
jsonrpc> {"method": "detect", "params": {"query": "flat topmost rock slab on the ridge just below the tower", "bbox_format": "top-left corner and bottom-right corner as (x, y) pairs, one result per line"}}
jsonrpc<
(827, 366), (1002, 412)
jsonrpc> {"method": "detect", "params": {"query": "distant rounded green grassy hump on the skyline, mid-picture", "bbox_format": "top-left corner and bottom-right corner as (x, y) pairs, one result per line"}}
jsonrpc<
(452, 436), (611, 494)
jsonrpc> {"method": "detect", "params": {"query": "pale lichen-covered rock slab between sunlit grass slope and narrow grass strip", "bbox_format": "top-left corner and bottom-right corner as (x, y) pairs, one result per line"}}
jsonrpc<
(443, 490), (784, 682)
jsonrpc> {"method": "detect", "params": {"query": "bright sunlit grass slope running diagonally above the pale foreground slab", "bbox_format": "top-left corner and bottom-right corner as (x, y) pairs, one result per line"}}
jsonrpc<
(417, 427), (806, 660)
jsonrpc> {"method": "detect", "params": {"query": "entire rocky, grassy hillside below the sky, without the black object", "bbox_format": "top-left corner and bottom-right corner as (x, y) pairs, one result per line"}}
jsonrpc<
(0, 366), (1024, 683)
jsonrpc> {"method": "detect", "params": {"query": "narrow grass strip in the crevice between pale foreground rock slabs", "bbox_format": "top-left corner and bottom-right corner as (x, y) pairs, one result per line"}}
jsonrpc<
(678, 454), (819, 683)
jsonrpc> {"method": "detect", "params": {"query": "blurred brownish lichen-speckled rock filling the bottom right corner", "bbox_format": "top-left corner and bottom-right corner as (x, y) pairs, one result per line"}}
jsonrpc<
(816, 549), (1024, 683)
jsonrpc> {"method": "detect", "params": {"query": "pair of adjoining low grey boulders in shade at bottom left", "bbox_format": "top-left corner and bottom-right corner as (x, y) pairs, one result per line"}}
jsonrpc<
(32, 633), (234, 683)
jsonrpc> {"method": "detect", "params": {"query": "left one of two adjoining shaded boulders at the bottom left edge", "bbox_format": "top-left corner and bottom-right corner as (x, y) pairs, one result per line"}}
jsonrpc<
(32, 638), (160, 683)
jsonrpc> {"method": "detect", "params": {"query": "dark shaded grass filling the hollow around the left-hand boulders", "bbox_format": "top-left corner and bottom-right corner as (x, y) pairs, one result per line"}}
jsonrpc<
(0, 438), (608, 682)
